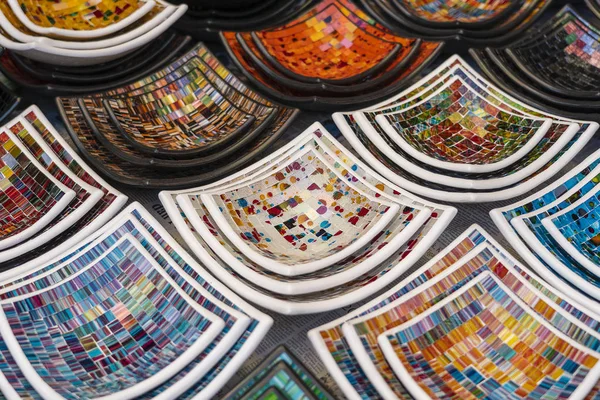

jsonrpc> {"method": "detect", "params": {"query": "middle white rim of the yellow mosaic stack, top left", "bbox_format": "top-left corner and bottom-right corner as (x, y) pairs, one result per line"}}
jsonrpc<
(0, 5), (177, 50)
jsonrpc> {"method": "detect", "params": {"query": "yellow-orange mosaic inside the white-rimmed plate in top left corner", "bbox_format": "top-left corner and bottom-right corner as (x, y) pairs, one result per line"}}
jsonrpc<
(19, 0), (144, 30)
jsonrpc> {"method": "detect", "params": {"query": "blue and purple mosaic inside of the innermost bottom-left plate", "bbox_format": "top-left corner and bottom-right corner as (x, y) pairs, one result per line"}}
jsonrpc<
(2, 239), (220, 398)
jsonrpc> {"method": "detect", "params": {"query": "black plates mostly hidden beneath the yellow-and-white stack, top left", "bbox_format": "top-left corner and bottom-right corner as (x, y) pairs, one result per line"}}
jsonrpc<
(0, 32), (191, 94)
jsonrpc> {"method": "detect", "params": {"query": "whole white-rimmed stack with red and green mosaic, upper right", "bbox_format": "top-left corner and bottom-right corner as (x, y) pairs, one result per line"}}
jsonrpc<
(333, 56), (598, 202)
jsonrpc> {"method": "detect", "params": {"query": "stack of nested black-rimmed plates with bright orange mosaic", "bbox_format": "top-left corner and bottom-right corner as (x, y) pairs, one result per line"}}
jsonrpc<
(221, 0), (442, 111)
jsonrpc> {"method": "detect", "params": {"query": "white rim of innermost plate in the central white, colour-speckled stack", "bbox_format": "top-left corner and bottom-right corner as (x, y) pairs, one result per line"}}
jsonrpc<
(200, 155), (400, 276)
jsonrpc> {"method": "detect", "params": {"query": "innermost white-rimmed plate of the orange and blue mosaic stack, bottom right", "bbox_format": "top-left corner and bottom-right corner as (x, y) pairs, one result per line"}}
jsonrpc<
(378, 271), (600, 399)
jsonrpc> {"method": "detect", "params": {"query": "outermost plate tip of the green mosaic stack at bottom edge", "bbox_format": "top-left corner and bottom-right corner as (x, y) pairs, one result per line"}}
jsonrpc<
(223, 346), (333, 400)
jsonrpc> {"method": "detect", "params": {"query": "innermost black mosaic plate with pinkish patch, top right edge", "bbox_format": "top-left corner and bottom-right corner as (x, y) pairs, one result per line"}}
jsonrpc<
(505, 7), (600, 100)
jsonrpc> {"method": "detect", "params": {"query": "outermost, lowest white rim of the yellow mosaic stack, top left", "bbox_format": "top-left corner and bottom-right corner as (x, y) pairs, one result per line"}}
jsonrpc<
(0, 4), (187, 66)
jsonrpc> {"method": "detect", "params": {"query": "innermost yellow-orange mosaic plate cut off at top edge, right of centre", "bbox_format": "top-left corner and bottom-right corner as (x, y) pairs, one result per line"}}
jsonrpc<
(392, 0), (520, 29)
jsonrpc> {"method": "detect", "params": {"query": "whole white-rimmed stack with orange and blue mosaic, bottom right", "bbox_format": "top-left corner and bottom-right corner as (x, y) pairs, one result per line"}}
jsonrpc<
(309, 225), (600, 399)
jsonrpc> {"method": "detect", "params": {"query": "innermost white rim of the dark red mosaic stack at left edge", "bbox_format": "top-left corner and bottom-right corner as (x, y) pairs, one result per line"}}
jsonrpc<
(0, 126), (75, 250)
